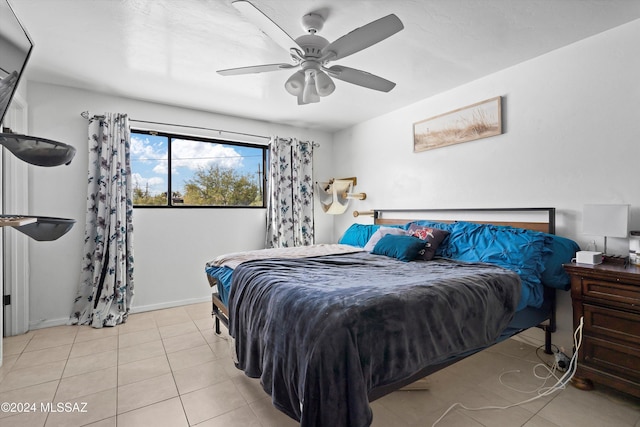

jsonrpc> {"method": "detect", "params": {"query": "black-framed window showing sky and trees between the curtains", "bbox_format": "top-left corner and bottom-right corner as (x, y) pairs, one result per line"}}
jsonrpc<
(131, 130), (267, 208)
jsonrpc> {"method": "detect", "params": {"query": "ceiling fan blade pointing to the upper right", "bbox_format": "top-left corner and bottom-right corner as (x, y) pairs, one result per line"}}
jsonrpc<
(322, 13), (404, 60)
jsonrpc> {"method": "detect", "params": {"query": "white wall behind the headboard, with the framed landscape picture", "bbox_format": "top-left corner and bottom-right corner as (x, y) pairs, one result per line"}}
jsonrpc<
(333, 20), (640, 351)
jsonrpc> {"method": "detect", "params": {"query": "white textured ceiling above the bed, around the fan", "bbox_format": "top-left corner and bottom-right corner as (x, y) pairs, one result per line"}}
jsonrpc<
(10, 0), (640, 131)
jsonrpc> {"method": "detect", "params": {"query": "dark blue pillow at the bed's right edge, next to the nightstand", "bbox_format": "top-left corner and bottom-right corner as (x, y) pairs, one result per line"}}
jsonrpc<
(541, 234), (580, 291)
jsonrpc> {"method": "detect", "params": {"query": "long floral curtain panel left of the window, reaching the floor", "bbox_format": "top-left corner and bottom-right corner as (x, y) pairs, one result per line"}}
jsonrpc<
(70, 113), (134, 328)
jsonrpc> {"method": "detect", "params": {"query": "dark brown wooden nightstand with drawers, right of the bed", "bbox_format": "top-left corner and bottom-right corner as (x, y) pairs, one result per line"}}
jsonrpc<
(564, 263), (640, 397)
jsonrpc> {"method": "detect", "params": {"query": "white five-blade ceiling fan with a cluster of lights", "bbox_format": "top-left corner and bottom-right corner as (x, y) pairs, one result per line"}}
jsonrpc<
(218, 0), (404, 105)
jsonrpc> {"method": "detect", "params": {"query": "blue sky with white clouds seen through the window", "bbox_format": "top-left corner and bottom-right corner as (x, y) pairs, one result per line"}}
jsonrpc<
(131, 132), (264, 195)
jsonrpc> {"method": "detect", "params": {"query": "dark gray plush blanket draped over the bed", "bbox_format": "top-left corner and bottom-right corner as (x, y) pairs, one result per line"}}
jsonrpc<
(229, 253), (520, 427)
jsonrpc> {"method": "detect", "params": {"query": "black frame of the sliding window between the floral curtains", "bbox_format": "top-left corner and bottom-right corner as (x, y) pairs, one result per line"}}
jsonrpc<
(130, 128), (269, 209)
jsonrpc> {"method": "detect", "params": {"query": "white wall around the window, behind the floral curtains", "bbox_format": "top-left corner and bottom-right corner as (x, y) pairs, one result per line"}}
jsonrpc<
(22, 81), (332, 329)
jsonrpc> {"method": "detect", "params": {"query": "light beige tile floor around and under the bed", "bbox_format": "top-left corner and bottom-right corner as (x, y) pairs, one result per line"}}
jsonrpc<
(0, 303), (640, 427)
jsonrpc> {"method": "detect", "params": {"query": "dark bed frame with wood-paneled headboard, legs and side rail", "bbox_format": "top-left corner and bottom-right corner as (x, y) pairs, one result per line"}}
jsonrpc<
(207, 208), (556, 388)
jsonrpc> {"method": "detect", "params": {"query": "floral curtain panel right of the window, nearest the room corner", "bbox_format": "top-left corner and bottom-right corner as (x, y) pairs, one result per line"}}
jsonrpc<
(266, 136), (314, 248)
